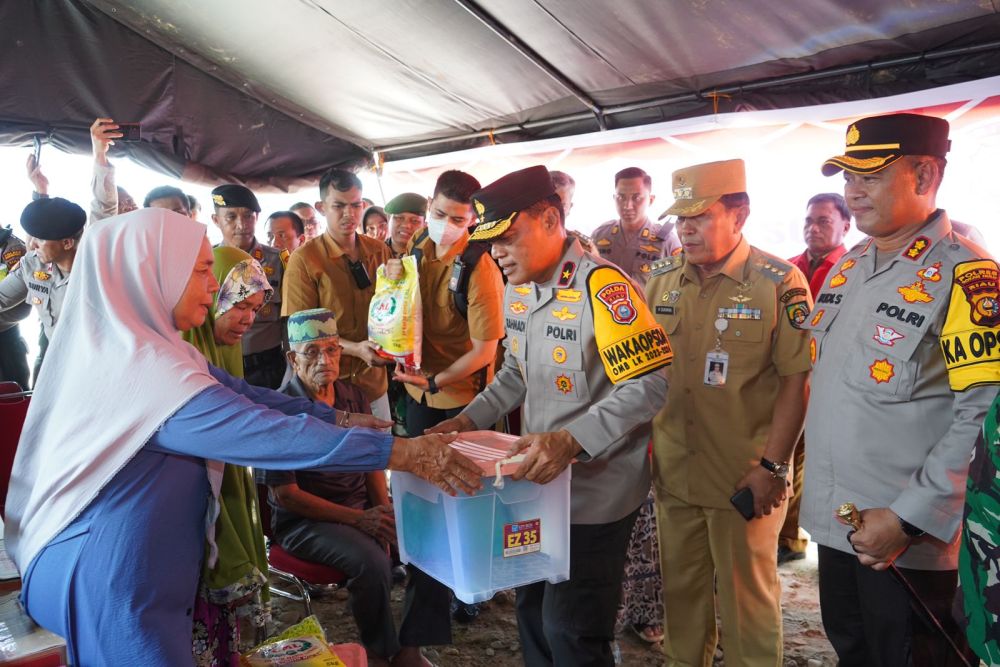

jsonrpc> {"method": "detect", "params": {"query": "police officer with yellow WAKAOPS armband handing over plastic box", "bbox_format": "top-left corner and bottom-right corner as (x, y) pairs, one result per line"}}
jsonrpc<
(430, 166), (672, 667)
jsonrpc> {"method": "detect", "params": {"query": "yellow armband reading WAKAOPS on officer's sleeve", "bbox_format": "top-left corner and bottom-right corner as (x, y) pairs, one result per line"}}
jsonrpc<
(587, 266), (674, 384)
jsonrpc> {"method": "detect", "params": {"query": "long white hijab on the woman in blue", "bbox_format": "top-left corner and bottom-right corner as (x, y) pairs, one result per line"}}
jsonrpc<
(5, 208), (216, 572)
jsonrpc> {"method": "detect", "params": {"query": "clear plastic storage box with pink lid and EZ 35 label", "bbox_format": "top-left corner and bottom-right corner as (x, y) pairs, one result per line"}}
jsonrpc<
(392, 431), (571, 603)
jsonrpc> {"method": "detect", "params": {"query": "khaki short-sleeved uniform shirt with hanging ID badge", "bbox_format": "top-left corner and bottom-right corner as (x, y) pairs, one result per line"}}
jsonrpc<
(646, 239), (812, 511)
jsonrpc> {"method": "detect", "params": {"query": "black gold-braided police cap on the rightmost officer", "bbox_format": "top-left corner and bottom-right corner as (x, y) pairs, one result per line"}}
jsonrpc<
(823, 113), (951, 176)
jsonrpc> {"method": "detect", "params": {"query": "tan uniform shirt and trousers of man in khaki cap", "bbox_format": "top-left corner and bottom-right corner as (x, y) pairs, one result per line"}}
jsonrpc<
(646, 239), (811, 666)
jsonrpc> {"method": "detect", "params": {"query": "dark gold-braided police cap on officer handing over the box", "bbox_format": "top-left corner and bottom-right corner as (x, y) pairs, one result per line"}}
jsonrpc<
(469, 165), (556, 241)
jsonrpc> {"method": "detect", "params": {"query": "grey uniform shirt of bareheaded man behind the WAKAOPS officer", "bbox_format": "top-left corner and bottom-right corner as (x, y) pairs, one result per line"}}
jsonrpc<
(590, 218), (681, 287)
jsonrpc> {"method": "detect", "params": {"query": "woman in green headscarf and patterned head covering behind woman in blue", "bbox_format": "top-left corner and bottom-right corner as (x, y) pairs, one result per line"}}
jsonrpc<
(184, 246), (273, 667)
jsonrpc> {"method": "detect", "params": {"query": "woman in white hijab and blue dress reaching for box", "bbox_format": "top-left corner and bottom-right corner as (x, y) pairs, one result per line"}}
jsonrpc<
(6, 209), (480, 667)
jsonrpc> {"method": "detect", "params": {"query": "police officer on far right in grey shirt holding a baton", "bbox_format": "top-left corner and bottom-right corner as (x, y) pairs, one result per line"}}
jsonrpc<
(802, 114), (1000, 665)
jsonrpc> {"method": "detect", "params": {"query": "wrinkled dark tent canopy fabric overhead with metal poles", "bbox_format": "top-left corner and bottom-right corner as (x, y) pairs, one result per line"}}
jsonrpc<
(0, 0), (1000, 189)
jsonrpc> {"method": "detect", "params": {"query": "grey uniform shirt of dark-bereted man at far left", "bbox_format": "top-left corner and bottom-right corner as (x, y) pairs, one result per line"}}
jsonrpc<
(0, 252), (69, 340)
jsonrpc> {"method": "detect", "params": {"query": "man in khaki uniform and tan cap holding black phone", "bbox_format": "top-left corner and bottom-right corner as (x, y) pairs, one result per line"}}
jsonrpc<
(646, 160), (812, 667)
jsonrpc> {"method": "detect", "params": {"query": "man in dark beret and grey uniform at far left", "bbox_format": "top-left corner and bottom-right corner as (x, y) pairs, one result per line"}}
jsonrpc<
(0, 197), (87, 378)
